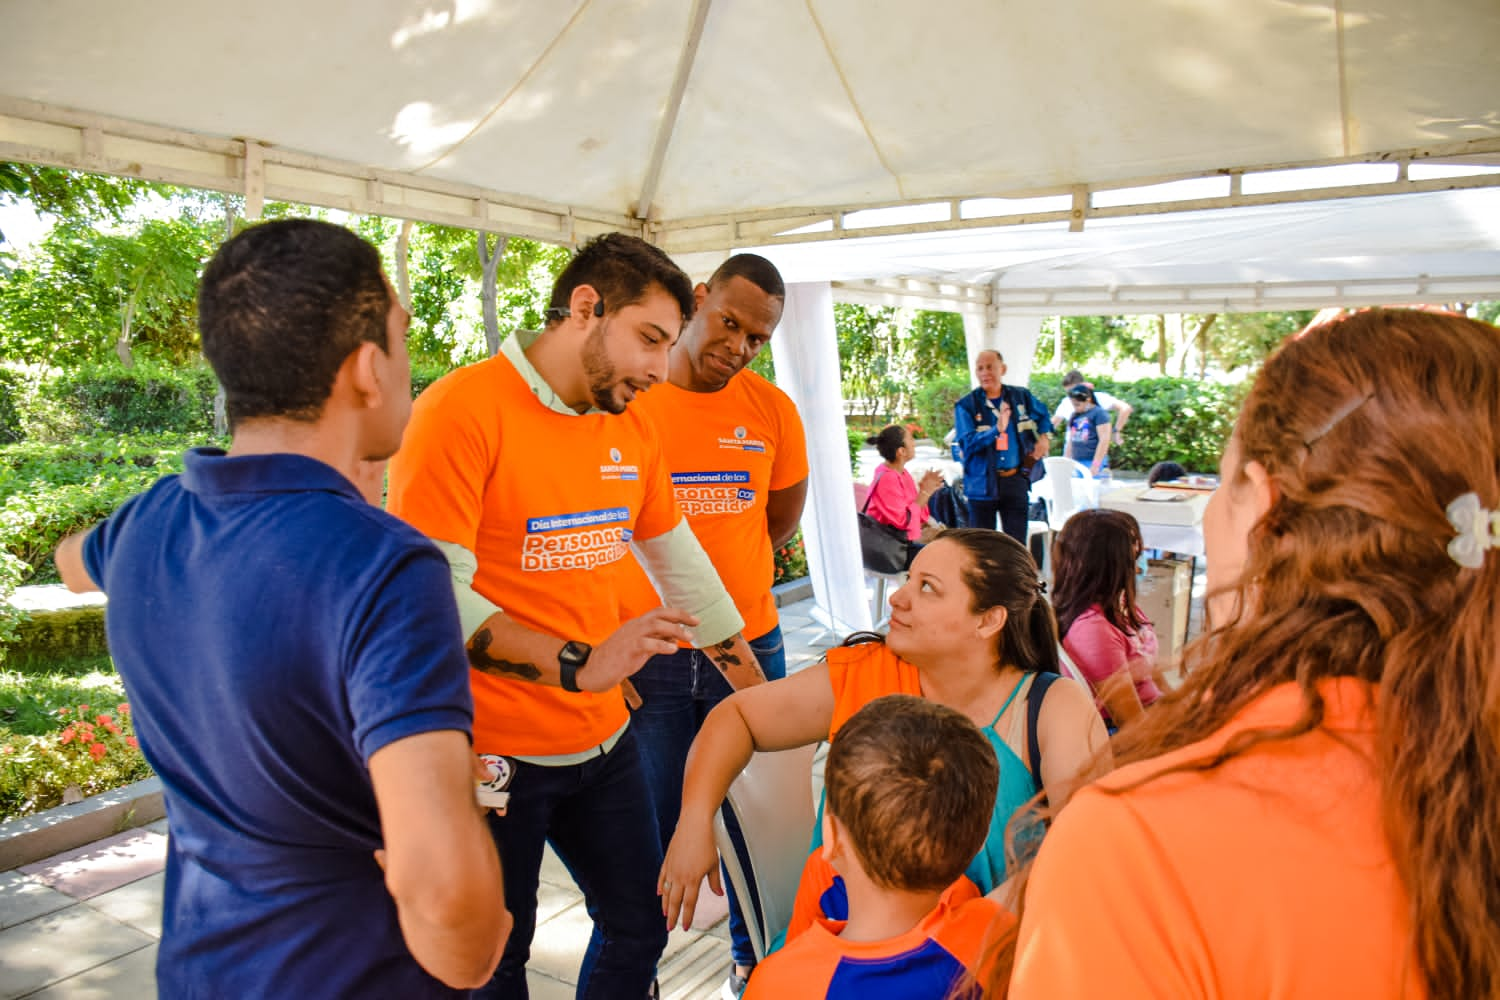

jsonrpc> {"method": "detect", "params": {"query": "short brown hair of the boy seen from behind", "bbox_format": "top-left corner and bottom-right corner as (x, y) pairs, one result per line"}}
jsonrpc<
(824, 694), (1001, 892)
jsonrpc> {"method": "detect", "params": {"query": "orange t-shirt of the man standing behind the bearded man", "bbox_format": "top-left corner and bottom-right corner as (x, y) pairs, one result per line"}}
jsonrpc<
(623, 370), (807, 639)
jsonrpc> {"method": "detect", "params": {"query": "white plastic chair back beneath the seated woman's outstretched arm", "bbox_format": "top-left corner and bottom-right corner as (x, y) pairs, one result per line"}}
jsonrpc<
(714, 744), (818, 960)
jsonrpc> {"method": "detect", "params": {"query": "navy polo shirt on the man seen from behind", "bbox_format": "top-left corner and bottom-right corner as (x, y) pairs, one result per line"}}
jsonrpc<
(84, 448), (474, 997)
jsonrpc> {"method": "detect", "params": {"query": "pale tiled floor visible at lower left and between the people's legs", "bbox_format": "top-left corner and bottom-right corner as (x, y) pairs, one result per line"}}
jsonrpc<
(0, 601), (831, 1000)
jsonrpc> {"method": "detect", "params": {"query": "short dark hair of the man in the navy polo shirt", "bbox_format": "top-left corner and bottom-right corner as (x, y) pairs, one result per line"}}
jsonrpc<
(198, 219), (390, 427)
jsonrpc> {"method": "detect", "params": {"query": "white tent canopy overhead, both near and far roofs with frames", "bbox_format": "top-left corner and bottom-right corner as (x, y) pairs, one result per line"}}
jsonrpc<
(0, 0), (1500, 632)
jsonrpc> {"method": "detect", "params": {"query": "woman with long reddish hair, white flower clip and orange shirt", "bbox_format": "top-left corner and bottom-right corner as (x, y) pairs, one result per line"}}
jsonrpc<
(992, 310), (1500, 1000)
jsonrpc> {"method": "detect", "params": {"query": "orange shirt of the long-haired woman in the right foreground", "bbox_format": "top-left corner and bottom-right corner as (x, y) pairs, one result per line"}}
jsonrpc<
(1011, 678), (1427, 1000)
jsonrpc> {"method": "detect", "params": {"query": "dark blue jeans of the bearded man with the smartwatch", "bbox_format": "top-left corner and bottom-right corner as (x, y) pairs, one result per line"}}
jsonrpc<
(471, 727), (666, 1000)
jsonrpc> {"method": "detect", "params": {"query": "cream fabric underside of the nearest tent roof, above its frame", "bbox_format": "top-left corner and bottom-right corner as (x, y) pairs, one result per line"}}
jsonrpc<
(0, 0), (1500, 250)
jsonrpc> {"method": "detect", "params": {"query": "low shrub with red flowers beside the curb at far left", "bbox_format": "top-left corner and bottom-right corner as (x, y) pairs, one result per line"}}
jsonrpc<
(0, 702), (152, 819)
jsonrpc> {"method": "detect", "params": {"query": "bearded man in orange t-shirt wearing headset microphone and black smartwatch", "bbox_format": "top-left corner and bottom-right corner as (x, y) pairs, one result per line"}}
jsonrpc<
(390, 234), (762, 1000)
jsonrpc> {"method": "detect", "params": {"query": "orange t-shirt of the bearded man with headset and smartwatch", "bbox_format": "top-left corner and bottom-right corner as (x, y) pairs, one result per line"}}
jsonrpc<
(389, 354), (681, 756)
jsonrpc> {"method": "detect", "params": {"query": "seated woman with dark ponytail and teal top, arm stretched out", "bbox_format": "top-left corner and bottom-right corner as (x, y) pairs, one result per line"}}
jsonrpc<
(660, 528), (1109, 937)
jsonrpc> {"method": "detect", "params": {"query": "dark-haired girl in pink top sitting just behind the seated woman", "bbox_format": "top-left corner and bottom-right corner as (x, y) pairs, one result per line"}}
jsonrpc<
(1052, 510), (1164, 726)
